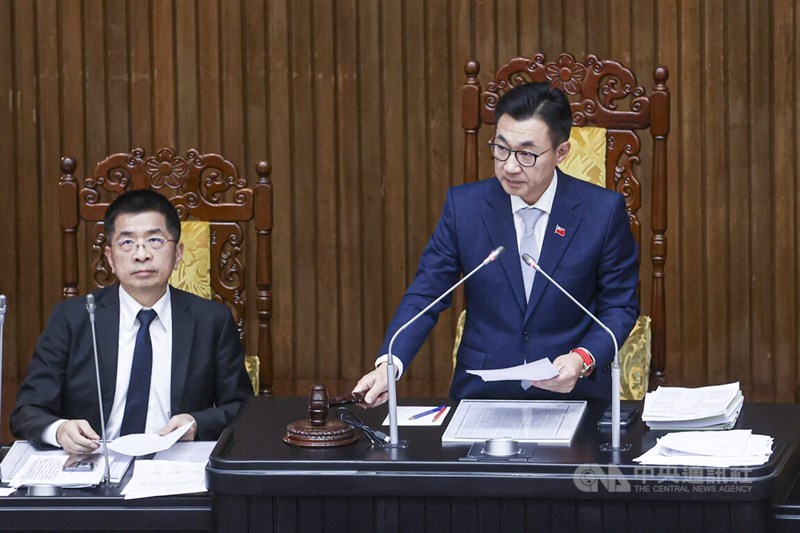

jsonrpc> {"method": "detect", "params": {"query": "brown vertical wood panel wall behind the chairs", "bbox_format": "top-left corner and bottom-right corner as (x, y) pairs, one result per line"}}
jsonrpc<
(0, 0), (800, 438)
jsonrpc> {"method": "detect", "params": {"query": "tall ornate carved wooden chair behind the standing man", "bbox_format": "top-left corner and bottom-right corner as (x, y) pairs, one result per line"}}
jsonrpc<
(454, 54), (670, 398)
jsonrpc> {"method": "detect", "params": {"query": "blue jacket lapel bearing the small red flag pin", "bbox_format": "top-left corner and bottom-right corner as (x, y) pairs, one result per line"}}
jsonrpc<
(524, 169), (582, 322)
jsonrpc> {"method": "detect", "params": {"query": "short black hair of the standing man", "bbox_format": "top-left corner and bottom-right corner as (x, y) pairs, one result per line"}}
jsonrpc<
(494, 82), (572, 148)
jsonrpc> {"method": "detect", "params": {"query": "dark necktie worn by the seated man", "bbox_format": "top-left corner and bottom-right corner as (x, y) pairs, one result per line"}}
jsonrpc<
(120, 309), (157, 435)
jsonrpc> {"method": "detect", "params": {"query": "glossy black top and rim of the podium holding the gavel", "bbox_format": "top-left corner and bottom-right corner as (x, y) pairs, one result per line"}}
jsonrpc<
(206, 397), (800, 502)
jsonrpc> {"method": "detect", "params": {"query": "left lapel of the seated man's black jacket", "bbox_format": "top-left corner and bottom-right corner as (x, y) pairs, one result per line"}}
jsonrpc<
(95, 284), (119, 420)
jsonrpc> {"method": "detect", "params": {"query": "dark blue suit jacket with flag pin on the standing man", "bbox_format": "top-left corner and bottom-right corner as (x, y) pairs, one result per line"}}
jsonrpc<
(381, 170), (639, 399)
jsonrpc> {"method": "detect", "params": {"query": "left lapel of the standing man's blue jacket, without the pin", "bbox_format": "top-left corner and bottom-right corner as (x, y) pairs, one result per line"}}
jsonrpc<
(481, 178), (526, 312)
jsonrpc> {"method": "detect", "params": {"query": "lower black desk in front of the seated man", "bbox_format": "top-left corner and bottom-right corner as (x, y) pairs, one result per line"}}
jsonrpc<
(0, 454), (212, 533)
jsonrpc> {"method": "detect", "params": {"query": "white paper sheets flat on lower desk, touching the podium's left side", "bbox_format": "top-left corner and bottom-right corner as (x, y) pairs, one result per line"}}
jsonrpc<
(122, 460), (206, 500)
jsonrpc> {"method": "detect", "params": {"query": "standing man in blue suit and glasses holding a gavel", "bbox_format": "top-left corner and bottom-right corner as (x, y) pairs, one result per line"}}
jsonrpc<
(354, 83), (639, 405)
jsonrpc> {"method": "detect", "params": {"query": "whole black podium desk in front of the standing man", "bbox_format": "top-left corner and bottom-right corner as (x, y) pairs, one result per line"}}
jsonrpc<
(206, 397), (800, 533)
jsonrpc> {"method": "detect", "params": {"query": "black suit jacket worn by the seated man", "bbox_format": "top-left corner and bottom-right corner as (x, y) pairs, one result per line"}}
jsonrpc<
(11, 285), (253, 445)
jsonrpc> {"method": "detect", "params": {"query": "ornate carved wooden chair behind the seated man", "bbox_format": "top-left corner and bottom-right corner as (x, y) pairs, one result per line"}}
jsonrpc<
(59, 148), (272, 394)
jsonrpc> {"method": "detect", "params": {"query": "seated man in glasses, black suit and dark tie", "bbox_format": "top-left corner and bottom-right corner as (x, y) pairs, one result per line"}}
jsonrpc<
(11, 190), (253, 453)
